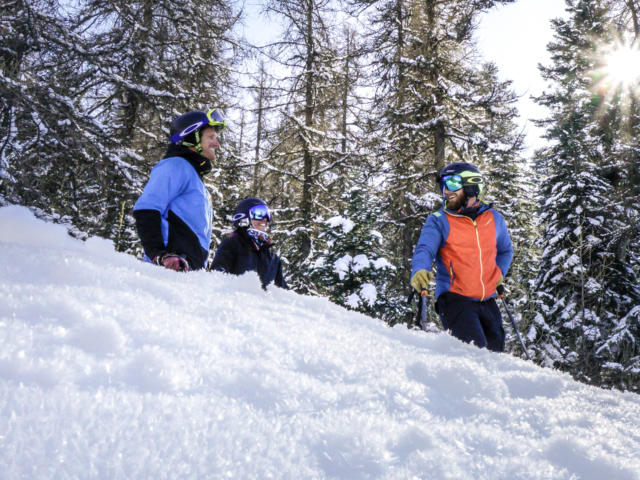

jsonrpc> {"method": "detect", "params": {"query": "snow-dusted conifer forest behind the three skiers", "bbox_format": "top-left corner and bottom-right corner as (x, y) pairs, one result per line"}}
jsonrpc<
(0, 0), (640, 393)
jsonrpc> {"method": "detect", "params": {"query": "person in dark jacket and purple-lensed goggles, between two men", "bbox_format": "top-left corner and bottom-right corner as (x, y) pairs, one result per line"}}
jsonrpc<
(211, 197), (288, 289)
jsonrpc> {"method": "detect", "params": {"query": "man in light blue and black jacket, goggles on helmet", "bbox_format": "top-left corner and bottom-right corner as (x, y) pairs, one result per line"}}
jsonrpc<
(133, 109), (225, 271)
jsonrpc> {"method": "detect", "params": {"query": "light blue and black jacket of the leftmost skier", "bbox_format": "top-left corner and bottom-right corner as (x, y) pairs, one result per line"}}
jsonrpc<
(133, 146), (213, 270)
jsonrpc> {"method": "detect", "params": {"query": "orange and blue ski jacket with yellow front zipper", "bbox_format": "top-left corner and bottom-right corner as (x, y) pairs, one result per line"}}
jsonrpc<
(411, 203), (513, 301)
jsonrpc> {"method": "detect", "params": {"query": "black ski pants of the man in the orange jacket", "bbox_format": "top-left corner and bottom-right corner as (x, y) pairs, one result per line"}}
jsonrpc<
(436, 292), (504, 352)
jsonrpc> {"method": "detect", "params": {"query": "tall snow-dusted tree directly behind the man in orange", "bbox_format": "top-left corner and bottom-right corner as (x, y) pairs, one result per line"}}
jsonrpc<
(358, 0), (521, 322)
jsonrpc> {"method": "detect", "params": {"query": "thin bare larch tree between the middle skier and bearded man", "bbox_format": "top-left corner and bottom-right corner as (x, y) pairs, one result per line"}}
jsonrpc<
(264, 0), (360, 291)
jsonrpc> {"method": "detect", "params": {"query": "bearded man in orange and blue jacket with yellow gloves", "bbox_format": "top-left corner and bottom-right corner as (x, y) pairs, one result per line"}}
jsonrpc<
(411, 162), (513, 352)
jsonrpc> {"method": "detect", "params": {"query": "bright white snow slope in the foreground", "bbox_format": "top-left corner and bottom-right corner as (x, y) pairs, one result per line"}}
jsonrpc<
(0, 207), (640, 480)
